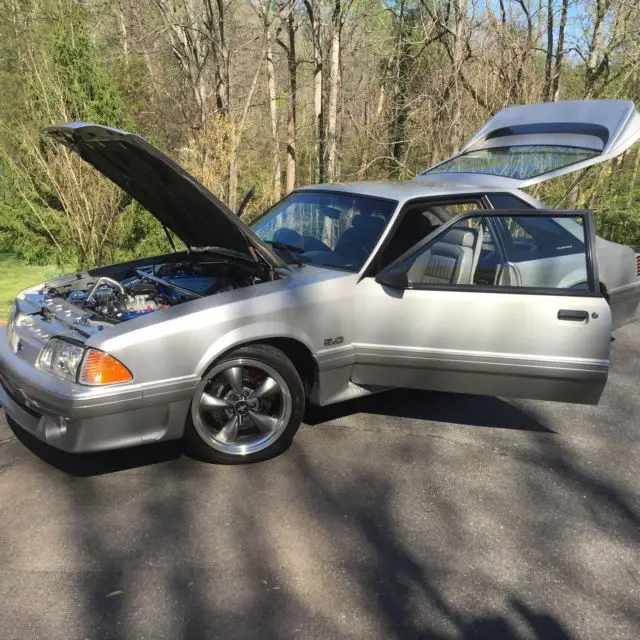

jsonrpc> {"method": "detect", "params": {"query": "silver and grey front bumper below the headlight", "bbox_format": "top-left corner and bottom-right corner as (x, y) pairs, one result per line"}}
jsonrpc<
(0, 329), (197, 453)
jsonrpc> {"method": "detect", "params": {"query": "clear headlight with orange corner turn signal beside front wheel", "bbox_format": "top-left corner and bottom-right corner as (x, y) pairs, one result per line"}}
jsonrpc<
(36, 338), (133, 386)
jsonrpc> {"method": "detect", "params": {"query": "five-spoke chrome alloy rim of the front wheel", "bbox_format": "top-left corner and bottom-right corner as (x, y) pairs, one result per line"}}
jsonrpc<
(191, 358), (291, 456)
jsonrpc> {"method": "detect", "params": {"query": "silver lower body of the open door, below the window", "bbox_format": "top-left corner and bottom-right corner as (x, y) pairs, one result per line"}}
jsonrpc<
(352, 278), (611, 404)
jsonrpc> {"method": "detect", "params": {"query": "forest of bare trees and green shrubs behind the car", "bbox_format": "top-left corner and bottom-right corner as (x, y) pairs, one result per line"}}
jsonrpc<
(0, 0), (640, 267)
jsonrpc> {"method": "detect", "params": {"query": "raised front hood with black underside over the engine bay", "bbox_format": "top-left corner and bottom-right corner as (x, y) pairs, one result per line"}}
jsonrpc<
(43, 122), (284, 267)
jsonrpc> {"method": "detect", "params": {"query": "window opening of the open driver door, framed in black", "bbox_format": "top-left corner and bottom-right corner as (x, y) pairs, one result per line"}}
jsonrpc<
(402, 213), (588, 289)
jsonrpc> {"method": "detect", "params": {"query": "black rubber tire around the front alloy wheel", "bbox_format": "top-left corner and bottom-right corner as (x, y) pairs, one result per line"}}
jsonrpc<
(185, 344), (305, 464)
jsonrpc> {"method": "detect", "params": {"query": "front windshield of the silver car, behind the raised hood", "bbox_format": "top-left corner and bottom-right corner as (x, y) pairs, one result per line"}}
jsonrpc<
(251, 191), (397, 271)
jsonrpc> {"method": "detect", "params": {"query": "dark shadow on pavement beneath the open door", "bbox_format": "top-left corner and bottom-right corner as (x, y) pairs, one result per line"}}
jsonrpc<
(305, 389), (555, 433)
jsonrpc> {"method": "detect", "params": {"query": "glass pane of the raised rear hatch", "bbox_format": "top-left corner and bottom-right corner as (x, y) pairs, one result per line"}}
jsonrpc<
(427, 144), (600, 180)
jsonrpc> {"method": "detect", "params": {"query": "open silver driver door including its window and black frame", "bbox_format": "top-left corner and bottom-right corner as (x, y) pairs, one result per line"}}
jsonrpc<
(352, 210), (611, 404)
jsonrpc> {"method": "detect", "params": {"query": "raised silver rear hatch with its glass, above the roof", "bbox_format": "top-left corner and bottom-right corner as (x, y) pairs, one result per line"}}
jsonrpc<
(419, 100), (640, 188)
